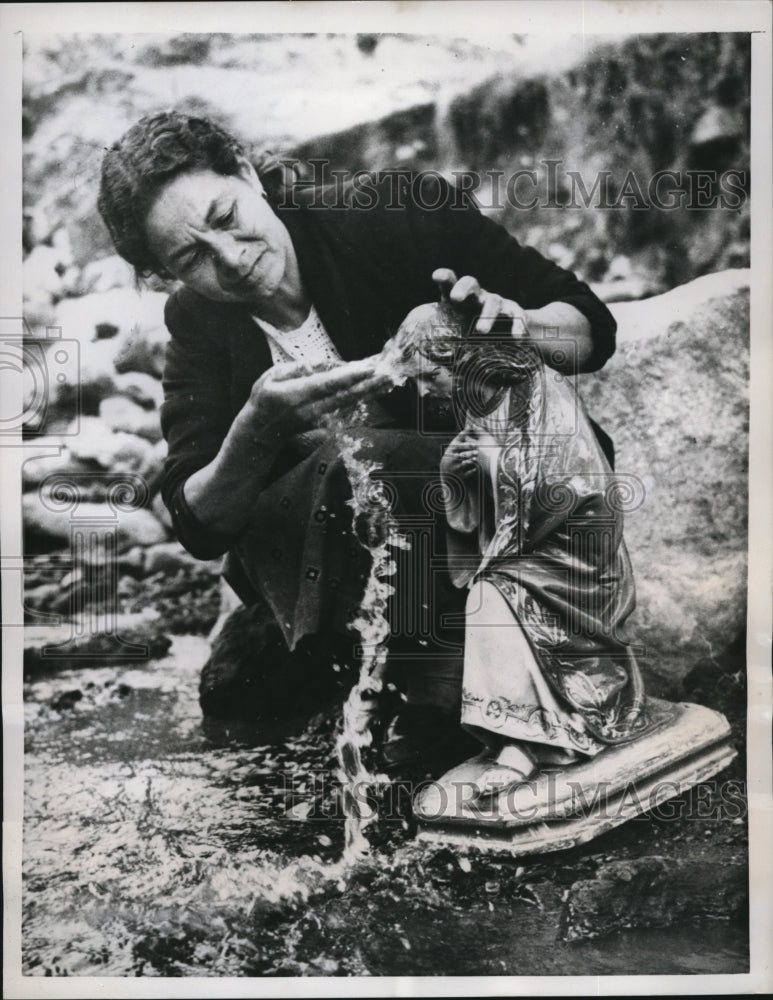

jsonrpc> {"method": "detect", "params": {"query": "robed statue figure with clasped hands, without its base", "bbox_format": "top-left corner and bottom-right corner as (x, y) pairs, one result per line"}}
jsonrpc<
(390, 305), (647, 798)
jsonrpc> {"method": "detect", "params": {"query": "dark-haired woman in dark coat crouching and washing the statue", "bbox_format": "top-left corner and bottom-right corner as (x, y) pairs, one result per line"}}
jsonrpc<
(99, 112), (615, 764)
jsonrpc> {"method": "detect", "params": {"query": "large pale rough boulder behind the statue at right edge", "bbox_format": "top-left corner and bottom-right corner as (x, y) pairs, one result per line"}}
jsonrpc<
(578, 270), (749, 682)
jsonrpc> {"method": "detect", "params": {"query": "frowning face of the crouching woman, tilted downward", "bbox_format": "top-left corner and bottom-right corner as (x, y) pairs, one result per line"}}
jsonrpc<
(145, 161), (297, 306)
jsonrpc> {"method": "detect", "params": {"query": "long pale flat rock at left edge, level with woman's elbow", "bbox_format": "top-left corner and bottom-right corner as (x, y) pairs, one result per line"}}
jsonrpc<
(22, 493), (167, 552)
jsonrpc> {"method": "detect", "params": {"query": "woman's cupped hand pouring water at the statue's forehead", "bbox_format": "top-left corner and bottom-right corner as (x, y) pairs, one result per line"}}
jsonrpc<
(248, 358), (391, 437)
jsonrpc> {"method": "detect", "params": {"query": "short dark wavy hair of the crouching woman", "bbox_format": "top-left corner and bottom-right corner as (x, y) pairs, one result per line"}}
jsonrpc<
(97, 111), (282, 278)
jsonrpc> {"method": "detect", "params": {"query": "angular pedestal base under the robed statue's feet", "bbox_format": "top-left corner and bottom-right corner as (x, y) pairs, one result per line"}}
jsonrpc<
(413, 698), (736, 856)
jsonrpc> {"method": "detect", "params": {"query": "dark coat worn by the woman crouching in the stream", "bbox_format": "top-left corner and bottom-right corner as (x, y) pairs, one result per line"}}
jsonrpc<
(161, 175), (616, 580)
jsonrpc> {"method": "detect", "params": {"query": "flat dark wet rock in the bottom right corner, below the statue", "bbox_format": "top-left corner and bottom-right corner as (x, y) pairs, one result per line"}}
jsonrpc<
(564, 857), (748, 941)
